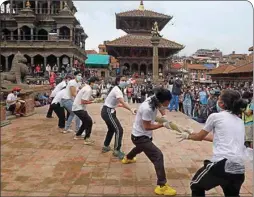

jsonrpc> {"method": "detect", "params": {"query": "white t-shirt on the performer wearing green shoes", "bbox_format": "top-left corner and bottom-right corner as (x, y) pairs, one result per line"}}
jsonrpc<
(104, 86), (123, 108)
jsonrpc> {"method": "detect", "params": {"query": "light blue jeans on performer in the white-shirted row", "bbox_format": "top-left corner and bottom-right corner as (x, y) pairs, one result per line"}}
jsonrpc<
(61, 99), (80, 131)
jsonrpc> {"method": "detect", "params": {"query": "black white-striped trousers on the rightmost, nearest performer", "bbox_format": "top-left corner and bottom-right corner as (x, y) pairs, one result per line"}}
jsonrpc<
(190, 159), (245, 197)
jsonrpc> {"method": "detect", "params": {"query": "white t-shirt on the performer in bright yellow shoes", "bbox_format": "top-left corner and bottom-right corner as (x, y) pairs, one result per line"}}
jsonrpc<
(132, 97), (158, 138)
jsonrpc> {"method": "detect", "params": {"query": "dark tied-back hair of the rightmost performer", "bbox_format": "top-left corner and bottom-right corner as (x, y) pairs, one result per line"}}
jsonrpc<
(220, 90), (248, 115)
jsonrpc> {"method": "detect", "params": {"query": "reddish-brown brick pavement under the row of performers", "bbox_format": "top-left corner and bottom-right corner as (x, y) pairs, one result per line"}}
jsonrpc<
(1, 104), (253, 196)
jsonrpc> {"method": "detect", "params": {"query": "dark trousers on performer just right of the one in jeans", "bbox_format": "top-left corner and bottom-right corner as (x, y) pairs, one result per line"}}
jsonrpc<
(73, 110), (93, 139)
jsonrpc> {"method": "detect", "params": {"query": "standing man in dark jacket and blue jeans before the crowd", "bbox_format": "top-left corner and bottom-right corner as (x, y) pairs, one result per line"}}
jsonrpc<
(169, 76), (183, 111)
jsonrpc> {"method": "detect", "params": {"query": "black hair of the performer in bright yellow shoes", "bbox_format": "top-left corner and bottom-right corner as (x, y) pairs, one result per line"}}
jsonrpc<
(149, 88), (172, 111)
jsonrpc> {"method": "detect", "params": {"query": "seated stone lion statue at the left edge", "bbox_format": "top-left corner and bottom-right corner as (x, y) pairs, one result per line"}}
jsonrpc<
(1, 52), (29, 84)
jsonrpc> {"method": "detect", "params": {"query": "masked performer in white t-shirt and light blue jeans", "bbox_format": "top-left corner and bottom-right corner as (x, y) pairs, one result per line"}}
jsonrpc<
(61, 71), (83, 134)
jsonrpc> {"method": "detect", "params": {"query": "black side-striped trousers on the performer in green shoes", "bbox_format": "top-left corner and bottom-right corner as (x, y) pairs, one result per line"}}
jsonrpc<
(101, 106), (123, 150)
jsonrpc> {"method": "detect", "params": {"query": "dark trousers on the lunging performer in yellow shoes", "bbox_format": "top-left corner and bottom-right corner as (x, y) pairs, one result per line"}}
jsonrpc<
(126, 135), (167, 185)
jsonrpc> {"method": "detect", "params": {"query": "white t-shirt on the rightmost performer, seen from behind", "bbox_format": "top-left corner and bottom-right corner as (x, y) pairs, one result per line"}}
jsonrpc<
(204, 111), (245, 162)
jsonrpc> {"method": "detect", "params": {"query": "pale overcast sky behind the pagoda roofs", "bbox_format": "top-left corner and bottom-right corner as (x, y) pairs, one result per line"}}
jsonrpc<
(0, 0), (253, 55)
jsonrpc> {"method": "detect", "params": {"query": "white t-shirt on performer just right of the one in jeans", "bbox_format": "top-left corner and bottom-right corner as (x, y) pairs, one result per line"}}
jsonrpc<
(72, 84), (92, 111)
